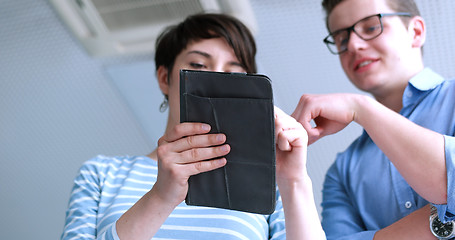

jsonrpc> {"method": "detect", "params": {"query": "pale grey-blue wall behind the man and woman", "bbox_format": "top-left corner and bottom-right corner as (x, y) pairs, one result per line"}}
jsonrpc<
(0, 0), (455, 239)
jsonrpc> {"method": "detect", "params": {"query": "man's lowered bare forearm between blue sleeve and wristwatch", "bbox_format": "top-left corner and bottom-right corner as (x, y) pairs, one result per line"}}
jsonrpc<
(374, 205), (436, 240)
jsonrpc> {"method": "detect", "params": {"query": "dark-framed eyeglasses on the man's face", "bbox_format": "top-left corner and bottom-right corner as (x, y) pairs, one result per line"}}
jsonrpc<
(323, 12), (412, 54)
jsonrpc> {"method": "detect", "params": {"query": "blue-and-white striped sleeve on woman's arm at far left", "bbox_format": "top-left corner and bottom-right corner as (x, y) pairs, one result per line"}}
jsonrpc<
(61, 159), (115, 240)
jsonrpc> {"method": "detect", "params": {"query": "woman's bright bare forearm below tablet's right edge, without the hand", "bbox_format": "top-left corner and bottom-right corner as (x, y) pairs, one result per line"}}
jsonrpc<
(278, 174), (325, 240)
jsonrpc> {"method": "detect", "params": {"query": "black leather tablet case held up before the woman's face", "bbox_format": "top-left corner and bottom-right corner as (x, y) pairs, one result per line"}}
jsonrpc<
(180, 70), (276, 214)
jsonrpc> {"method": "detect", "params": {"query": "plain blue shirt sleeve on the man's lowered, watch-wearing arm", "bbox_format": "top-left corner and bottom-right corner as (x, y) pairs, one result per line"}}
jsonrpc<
(322, 164), (376, 240)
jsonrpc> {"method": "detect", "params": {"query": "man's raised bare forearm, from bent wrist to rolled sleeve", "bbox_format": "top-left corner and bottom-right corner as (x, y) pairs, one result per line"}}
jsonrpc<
(354, 96), (447, 204)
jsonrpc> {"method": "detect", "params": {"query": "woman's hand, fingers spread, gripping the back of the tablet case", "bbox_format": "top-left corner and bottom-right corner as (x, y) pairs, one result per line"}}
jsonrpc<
(153, 123), (230, 206)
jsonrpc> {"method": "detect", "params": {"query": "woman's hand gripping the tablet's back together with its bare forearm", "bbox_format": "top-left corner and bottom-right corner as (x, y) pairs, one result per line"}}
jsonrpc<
(116, 123), (230, 239)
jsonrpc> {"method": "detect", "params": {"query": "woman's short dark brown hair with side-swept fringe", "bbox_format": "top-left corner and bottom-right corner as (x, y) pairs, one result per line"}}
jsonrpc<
(155, 13), (257, 73)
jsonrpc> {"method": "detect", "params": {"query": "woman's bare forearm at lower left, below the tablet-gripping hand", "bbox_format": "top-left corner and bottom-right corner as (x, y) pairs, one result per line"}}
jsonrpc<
(116, 189), (176, 240)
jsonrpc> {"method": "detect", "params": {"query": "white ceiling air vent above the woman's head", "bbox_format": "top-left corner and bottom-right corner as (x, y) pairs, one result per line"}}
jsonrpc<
(50, 0), (256, 56)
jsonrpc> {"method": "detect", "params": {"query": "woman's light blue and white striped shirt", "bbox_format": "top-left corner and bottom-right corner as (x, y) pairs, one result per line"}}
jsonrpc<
(61, 155), (286, 240)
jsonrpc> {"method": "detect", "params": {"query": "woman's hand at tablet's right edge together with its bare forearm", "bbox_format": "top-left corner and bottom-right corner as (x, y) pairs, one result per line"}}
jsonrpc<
(275, 107), (325, 240)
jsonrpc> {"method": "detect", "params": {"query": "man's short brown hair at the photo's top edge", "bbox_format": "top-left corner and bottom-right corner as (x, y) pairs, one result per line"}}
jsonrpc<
(322, 0), (420, 32)
